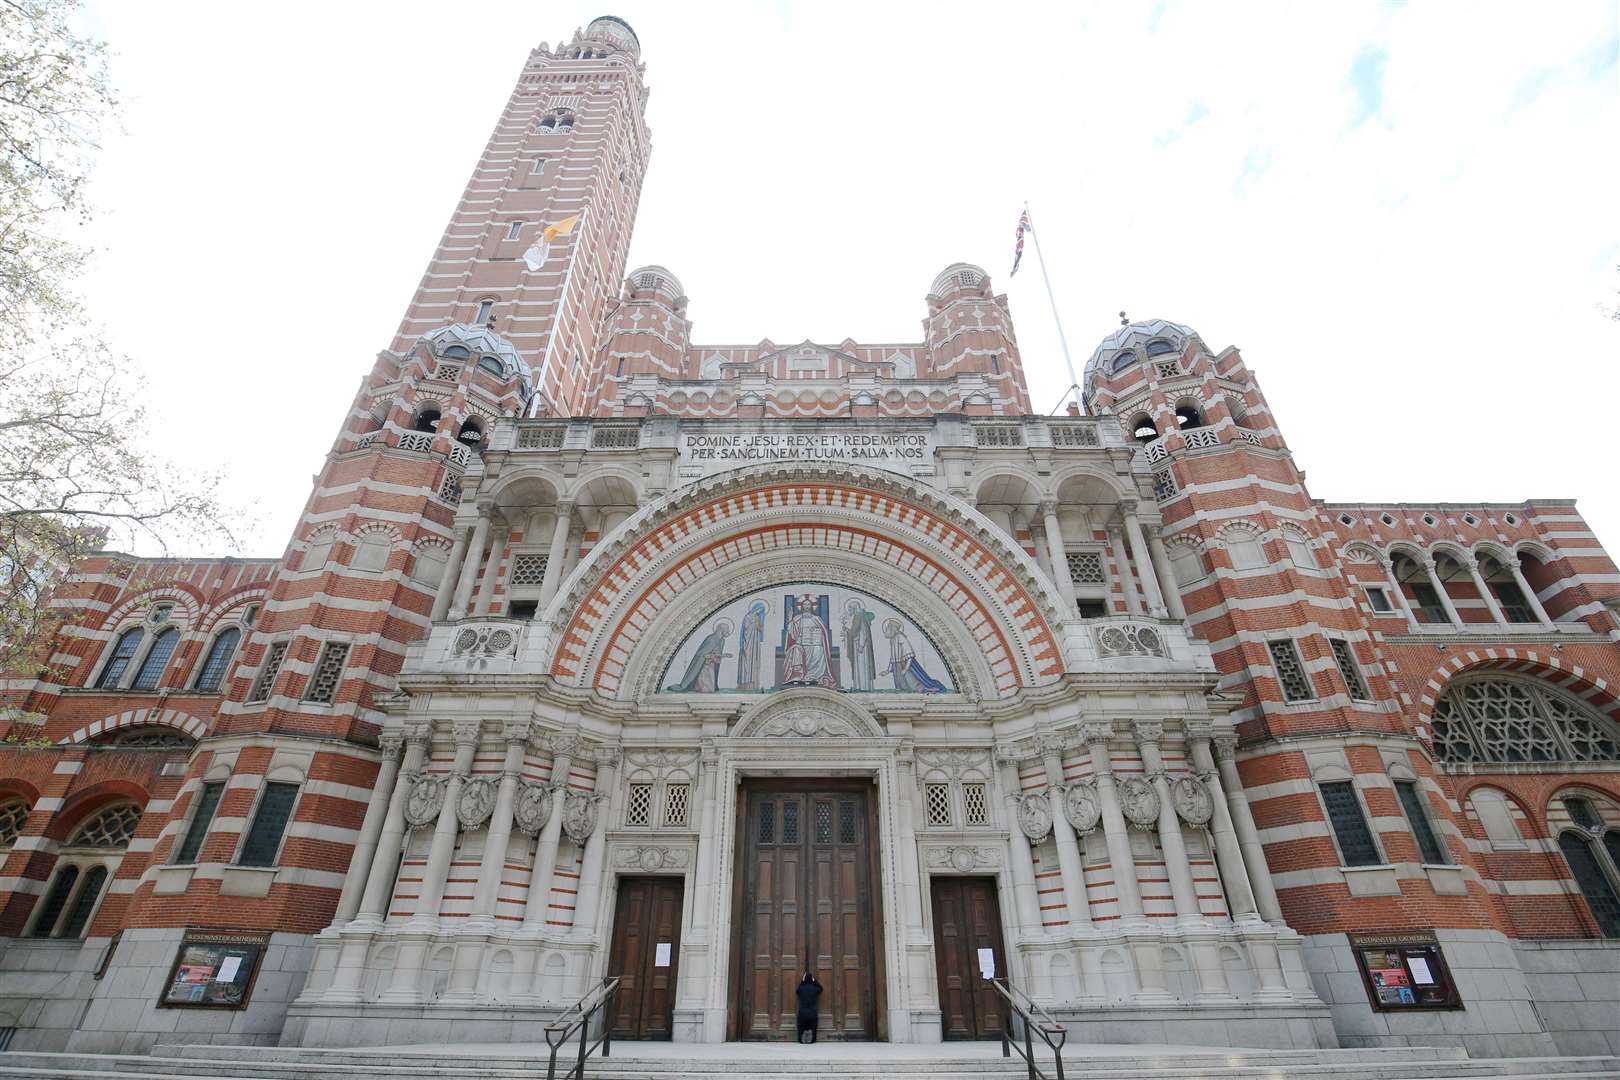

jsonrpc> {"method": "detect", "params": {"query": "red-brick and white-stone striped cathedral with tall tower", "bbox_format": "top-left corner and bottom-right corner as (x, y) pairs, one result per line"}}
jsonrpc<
(0, 16), (1620, 1054)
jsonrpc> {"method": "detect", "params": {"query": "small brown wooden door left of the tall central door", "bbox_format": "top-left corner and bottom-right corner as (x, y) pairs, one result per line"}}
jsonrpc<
(608, 878), (684, 1040)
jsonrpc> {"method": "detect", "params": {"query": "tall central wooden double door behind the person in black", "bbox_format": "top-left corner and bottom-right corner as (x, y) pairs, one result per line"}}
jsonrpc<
(731, 784), (883, 1041)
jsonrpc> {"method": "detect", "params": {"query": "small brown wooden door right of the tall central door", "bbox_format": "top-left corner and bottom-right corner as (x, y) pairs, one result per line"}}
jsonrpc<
(930, 878), (1006, 1040)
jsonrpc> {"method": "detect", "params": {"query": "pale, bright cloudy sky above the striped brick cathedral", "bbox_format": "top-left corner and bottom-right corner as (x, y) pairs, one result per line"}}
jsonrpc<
(84, 0), (1620, 555)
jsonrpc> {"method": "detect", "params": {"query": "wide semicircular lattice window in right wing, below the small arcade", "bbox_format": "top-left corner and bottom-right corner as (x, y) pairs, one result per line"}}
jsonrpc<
(1429, 674), (1620, 763)
